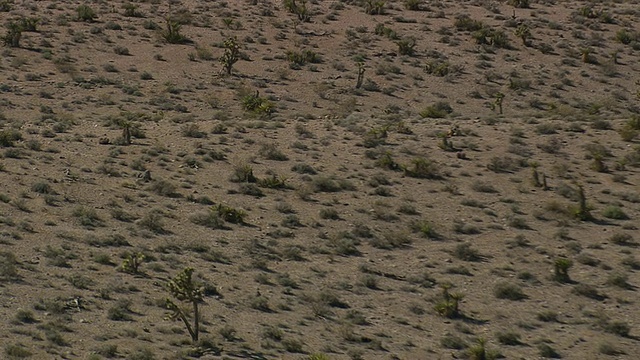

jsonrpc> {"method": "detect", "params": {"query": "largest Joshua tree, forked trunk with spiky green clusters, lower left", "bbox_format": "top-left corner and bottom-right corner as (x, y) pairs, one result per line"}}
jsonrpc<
(165, 267), (203, 343)
